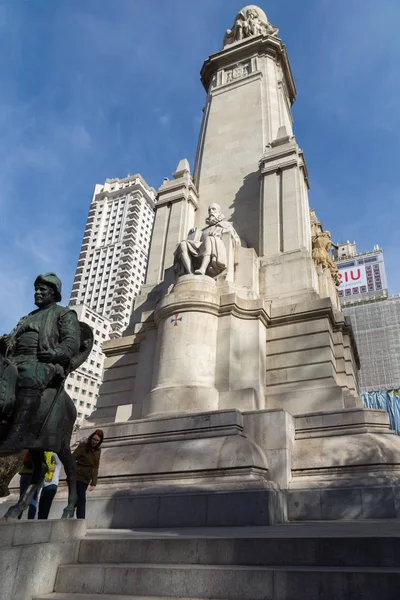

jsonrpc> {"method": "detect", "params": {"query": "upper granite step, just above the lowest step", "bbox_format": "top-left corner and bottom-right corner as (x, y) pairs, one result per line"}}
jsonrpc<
(78, 532), (400, 568)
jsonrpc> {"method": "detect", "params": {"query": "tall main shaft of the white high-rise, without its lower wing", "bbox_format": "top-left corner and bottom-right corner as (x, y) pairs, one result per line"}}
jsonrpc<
(70, 175), (156, 337)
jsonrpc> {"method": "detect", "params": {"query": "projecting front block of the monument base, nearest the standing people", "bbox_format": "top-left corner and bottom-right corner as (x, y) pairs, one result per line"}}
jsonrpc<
(70, 410), (286, 528)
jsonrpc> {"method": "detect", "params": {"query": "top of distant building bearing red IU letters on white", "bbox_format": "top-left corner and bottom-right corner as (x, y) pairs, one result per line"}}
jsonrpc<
(334, 242), (388, 306)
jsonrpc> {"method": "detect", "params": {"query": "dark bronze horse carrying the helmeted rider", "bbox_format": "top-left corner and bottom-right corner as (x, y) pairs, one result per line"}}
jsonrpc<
(0, 322), (93, 520)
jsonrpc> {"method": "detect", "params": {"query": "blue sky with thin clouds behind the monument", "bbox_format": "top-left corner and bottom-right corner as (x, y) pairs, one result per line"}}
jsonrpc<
(0, 0), (400, 332)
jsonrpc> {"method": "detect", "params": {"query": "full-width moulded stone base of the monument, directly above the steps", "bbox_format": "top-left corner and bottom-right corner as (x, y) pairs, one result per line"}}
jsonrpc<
(3, 408), (390, 528)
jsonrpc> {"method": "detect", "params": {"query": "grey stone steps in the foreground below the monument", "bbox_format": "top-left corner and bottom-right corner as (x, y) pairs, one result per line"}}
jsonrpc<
(34, 521), (400, 600)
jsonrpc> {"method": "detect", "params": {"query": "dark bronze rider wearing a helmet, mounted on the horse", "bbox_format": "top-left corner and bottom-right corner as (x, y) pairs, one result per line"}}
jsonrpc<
(0, 273), (81, 455)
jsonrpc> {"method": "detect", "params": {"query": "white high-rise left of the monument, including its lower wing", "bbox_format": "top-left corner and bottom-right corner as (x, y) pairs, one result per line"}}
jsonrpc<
(66, 175), (156, 424)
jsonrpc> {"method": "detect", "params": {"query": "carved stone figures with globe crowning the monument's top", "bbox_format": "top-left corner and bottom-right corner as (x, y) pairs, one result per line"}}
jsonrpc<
(223, 5), (278, 48)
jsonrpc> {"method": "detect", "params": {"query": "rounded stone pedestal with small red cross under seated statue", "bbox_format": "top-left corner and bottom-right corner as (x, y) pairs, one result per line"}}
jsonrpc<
(145, 275), (219, 416)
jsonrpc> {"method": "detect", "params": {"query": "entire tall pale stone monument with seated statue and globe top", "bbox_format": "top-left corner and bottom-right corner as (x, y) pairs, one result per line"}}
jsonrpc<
(86, 5), (398, 526)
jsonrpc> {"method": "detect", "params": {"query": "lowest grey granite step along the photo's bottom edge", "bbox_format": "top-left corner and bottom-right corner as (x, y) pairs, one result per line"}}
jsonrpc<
(53, 563), (400, 600)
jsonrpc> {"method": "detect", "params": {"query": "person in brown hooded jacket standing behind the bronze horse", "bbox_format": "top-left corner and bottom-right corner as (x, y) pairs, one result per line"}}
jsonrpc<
(72, 429), (104, 519)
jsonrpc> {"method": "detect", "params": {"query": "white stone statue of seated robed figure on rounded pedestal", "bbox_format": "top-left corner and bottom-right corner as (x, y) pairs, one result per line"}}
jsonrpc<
(174, 204), (240, 277)
